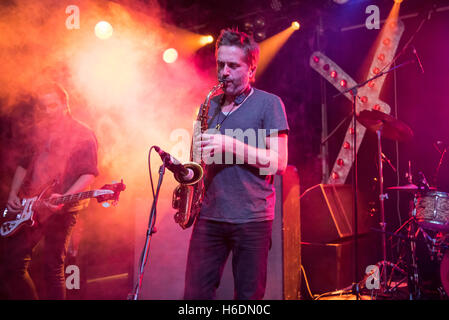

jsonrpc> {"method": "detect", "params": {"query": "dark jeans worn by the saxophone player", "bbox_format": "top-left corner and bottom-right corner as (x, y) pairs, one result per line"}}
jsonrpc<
(184, 219), (272, 300)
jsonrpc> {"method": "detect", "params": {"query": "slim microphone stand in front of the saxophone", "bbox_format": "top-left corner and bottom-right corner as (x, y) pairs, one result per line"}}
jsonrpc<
(128, 163), (165, 300)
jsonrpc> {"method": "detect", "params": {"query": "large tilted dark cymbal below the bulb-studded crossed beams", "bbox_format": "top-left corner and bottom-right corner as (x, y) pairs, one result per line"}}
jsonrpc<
(357, 110), (413, 141)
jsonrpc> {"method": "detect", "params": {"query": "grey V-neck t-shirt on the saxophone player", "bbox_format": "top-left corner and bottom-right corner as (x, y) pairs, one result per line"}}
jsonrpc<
(199, 88), (289, 223)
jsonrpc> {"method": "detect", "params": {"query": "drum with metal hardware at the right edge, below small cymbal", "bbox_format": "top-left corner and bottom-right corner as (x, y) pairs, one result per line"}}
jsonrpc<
(414, 191), (449, 232)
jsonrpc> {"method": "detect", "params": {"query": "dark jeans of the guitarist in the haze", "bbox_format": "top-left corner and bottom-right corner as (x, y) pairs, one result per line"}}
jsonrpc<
(0, 212), (78, 300)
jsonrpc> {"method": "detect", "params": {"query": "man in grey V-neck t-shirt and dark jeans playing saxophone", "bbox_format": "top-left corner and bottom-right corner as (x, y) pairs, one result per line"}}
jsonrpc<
(184, 29), (289, 300)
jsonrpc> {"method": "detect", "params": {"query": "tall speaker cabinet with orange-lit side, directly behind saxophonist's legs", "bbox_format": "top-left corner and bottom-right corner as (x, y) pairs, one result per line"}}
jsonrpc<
(217, 166), (301, 300)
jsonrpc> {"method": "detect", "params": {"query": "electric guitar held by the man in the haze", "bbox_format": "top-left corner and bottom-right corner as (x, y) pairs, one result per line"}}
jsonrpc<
(0, 180), (126, 237)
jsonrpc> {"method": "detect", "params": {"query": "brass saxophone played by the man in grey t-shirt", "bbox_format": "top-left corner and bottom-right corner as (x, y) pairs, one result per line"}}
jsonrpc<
(172, 81), (223, 229)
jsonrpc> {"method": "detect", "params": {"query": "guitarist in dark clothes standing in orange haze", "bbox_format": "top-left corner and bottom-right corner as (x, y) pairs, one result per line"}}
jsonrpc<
(0, 82), (98, 299)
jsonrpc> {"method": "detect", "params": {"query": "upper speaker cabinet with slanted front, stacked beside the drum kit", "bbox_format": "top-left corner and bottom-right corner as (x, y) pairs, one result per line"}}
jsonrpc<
(301, 184), (375, 243)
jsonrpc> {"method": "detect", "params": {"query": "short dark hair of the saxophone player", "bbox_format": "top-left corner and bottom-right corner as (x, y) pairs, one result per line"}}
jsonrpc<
(215, 29), (260, 80)
